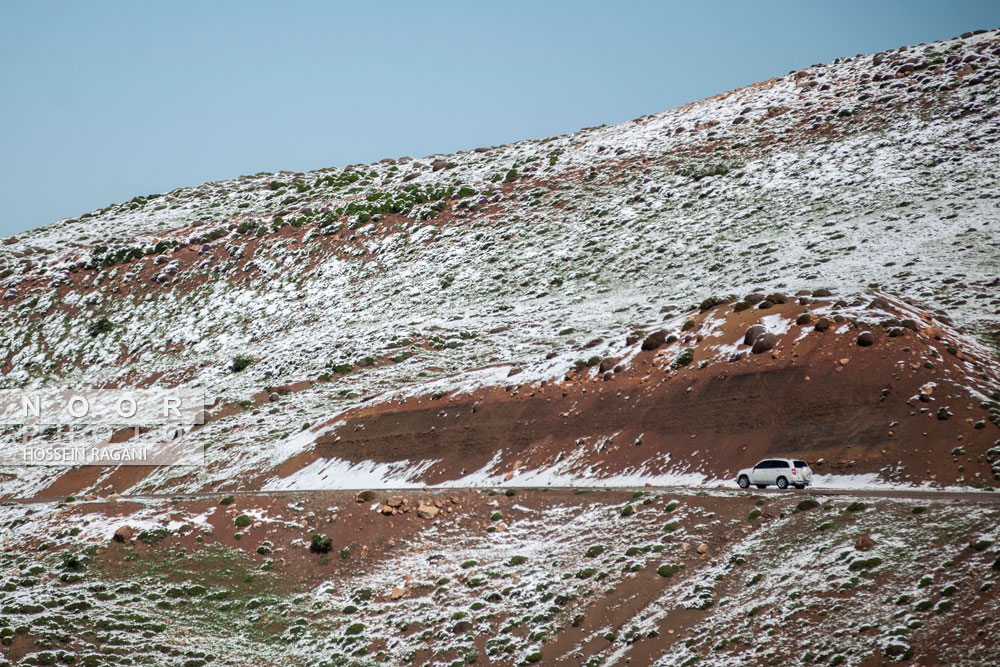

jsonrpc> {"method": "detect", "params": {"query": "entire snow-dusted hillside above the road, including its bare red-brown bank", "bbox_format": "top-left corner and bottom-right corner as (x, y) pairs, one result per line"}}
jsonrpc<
(0, 31), (1000, 495)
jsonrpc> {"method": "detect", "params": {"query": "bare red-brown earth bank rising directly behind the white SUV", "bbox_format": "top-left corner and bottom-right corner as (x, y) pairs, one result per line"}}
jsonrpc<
(274, 302), (1000, 484)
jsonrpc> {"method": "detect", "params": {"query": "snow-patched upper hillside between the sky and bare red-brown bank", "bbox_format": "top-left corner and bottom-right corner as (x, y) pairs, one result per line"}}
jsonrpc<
(0, 31), (1000, 498)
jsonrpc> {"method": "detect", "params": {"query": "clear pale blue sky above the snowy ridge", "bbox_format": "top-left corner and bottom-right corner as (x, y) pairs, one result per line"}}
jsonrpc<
(0, 0), (1000, 236)
